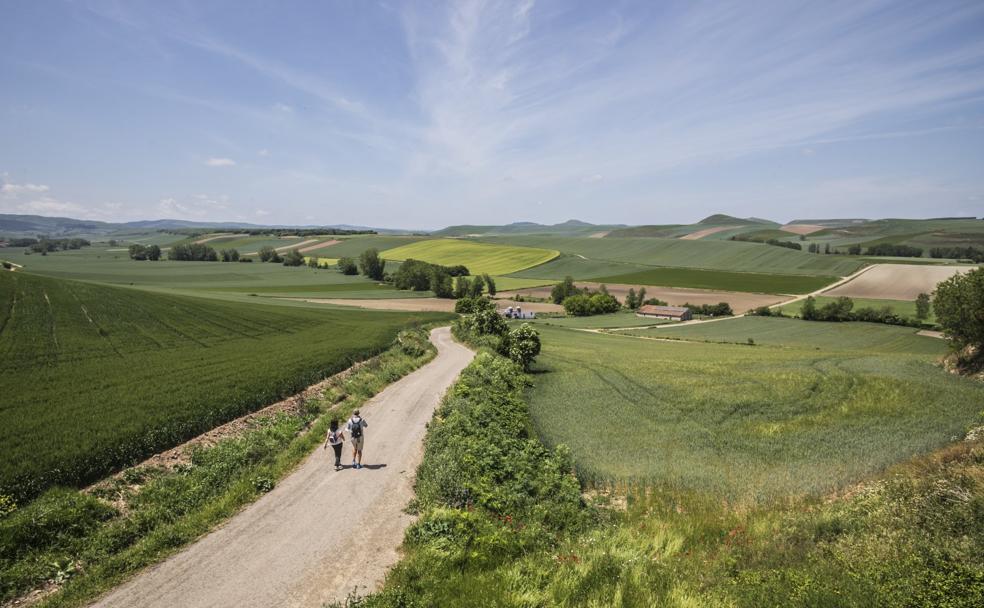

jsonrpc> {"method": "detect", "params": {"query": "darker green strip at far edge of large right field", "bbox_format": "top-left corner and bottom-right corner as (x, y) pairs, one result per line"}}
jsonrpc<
(625, 317), (947, 356)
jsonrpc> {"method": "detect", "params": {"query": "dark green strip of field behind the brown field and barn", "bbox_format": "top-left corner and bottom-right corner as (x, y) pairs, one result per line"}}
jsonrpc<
(592, 268), (837, 294)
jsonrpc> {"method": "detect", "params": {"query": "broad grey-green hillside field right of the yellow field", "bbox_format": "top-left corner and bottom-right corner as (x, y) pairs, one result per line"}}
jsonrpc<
(479, 236), (862, 280)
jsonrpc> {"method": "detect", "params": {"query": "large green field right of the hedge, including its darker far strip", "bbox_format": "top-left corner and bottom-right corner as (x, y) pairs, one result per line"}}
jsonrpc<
(530, 318), (984, 501)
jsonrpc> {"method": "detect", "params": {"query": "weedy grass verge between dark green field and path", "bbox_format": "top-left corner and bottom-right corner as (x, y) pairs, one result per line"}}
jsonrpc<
(0, 330), (436, 606)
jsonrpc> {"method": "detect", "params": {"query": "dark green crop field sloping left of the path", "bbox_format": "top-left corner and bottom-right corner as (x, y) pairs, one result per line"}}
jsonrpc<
(0, 270), (448, 497)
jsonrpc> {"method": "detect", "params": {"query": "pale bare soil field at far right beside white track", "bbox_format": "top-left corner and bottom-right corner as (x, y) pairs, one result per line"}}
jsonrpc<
(823, 264), (973, 300)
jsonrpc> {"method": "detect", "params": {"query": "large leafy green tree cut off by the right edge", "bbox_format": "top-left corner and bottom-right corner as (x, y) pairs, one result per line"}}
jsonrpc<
(933, 268), (984, 356)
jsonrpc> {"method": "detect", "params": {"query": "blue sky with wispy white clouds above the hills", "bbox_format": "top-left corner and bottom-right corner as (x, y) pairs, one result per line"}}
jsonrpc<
(0, 0), (984, 229)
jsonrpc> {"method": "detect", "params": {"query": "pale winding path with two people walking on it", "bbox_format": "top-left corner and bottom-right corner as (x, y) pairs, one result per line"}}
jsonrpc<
(94, 327), (474, 608)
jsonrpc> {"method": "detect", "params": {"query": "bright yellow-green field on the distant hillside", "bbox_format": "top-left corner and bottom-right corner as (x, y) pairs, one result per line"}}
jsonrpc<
(382, 239), (558, 275)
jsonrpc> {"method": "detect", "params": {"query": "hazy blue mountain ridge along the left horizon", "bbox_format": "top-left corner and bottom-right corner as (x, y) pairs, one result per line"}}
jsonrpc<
(0, 213), (413, 237)
